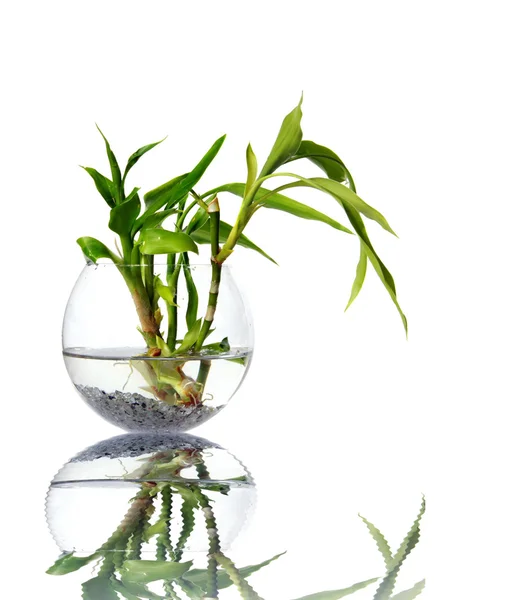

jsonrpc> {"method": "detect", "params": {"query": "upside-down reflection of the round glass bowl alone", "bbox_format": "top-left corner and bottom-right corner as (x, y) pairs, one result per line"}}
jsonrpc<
(46, 433), (256, 559)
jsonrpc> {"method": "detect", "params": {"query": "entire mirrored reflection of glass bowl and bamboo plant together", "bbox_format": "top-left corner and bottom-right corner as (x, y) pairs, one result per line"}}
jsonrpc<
(47, 434), (425, 600)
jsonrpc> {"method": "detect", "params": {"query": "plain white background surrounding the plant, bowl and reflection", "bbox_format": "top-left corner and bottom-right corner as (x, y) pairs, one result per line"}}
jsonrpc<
(0, 0), (520, 599)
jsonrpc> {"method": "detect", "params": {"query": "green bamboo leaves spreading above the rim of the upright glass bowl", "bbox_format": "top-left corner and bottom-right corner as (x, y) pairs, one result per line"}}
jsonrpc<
(78, 100), (407, 338)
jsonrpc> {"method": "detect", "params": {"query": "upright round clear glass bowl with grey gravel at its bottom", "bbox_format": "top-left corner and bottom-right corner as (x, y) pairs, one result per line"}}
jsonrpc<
(63, 260), (253, 432)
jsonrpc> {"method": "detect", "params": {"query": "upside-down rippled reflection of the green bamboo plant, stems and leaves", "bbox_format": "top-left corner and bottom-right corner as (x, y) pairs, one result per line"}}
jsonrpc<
(48, 450), (425, 600)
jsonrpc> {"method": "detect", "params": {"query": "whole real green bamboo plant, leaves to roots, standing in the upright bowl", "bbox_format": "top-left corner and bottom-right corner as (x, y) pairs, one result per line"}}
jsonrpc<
(78, 101), (406, 405)
